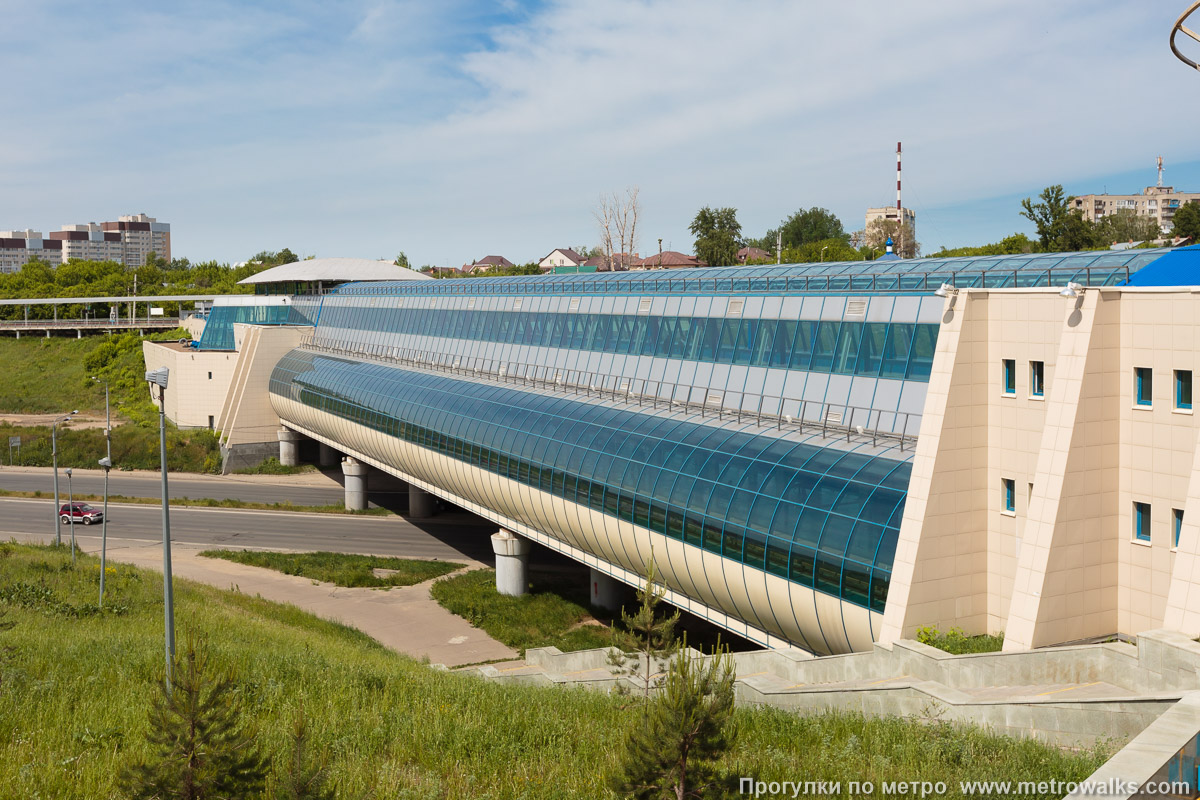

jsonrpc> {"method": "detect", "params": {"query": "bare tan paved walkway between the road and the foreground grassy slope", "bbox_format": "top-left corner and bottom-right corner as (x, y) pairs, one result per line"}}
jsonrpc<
(20, 535), (517, 667)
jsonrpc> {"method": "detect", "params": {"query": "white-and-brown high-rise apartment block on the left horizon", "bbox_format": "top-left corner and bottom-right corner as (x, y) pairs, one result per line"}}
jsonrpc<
(0, 213), (170, 272)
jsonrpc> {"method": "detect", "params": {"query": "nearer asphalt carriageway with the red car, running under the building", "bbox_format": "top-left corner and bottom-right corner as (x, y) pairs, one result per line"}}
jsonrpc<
(0, 498), (496, 564)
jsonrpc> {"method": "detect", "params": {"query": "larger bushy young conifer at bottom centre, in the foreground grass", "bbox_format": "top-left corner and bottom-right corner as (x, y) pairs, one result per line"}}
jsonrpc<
(611, 646), (737, 800)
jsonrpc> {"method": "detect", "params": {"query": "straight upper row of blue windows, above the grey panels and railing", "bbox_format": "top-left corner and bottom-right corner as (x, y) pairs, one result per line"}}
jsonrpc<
(320, 301), (937, 381)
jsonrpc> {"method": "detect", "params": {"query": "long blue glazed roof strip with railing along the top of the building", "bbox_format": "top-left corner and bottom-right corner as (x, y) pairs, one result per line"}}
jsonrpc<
(329, 265), (1133, 296)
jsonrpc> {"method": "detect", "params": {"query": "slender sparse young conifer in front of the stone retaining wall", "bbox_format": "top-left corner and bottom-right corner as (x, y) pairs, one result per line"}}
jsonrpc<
(608, 555), (679, 702)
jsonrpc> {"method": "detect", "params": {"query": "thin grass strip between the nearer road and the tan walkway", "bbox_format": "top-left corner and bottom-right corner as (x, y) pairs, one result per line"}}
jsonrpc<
(200, 551), (460, 587)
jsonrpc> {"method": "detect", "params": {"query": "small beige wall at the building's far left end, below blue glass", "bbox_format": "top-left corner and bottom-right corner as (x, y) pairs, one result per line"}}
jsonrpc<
(142, 342), (238, 428)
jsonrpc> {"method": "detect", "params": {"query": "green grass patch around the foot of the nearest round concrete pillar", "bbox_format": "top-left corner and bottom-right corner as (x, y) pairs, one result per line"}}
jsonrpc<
(431, 570), (633, 654)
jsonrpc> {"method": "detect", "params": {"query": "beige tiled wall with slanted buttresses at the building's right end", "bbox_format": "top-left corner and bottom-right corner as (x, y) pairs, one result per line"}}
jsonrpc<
(881, 288), (1200, 649)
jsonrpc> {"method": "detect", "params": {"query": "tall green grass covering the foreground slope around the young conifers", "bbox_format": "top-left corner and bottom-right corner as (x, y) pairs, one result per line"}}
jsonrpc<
(0, 545), (1106, 800)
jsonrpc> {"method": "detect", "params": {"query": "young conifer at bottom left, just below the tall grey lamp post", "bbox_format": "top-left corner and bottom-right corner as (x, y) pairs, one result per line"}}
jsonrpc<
(121, 640), (266, 800)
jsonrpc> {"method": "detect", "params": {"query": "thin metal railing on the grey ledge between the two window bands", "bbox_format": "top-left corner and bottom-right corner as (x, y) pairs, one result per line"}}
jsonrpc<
(300, 335), (920, 452)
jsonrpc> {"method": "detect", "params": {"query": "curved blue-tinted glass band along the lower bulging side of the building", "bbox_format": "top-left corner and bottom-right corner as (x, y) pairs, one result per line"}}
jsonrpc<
(271, 351), (911, 612)
